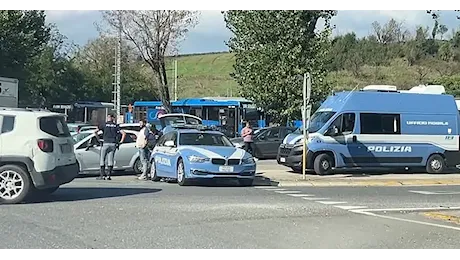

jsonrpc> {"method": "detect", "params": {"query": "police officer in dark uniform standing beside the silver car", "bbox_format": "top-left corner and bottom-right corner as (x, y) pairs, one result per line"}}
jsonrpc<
(96, 114), (126, 180)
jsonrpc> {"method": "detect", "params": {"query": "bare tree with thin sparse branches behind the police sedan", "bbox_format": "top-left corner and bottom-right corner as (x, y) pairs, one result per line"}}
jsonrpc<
(101, 9), (198, 113)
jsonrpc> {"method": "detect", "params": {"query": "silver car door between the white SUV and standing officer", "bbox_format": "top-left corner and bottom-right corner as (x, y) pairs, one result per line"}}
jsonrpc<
(75, 134), (101, 172)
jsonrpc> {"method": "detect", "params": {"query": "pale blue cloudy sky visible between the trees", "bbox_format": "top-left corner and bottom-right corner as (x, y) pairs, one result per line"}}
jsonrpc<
(46, 8), (460, 54)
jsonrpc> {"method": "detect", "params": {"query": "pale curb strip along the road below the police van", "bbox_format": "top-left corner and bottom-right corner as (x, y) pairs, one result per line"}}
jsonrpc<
(271, 179), (460, 187)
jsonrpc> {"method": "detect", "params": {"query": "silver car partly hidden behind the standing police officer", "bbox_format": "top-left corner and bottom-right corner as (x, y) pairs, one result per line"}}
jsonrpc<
(74, 130), (142, 174)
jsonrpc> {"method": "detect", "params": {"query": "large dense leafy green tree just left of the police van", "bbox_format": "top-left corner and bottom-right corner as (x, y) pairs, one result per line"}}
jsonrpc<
(224, 9), (335, 122)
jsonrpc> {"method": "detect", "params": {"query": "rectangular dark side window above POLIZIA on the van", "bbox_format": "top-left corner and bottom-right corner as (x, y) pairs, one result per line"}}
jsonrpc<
(359, 113), (401, 135)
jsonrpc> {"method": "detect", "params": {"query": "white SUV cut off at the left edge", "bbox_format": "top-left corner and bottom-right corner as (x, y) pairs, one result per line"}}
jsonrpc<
(0, 107), (78, 204)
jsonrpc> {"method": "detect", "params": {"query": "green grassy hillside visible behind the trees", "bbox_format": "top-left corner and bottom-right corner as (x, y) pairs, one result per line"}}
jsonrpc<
(164, 52), (458, 98)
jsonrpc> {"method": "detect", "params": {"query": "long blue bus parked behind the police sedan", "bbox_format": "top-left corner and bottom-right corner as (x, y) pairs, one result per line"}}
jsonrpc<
(133, 97), (267, 137)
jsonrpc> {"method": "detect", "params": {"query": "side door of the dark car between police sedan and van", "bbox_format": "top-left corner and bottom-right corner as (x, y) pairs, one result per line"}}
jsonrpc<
(254, 127), (283, 158)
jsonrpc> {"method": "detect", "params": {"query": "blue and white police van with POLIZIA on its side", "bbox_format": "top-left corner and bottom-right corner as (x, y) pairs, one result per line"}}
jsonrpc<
(277, 86), (460, 175)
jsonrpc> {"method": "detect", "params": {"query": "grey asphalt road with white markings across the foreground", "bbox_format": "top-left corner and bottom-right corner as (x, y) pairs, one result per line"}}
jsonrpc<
(0, 176), (460, 255)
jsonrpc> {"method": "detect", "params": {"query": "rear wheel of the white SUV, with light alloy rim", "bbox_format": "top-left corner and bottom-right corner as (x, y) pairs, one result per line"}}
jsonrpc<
(0, 165), (31, 204)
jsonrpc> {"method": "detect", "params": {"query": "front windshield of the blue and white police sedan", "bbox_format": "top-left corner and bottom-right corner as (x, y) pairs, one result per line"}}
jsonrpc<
(179, 133), (233, 146)
